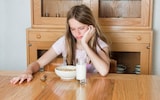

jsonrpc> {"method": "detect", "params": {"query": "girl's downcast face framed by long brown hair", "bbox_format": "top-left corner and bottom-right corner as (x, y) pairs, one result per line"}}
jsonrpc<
(69, 18), (89, 41)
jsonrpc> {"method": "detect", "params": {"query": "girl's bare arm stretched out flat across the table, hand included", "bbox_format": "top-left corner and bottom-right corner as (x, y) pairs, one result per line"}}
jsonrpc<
(10, 48), (57, 84)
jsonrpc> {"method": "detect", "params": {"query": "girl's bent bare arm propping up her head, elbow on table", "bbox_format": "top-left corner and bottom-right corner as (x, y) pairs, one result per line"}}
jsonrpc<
(81, 25), (110, 76)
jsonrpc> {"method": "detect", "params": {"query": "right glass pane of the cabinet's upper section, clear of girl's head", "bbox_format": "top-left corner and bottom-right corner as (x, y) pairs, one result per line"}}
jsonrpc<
(99, 0), (142, 18)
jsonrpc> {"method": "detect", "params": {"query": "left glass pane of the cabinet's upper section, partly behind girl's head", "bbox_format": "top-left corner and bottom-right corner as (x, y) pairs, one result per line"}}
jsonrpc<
(41, 0), (84, 17)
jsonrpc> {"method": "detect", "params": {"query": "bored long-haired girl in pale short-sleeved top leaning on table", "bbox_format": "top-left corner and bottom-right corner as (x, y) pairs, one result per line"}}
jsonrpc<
(10, 5), (110, 84)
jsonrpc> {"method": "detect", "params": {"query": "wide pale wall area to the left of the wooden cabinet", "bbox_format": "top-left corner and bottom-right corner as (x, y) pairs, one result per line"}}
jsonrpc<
(0, 0), (31, 70)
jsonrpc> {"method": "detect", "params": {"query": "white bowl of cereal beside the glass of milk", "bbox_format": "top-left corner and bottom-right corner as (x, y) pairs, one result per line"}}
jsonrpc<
(55, 65), (76, 80)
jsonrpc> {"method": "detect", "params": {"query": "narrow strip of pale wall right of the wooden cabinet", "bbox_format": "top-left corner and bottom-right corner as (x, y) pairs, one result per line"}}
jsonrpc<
(153, 0), (160, 75)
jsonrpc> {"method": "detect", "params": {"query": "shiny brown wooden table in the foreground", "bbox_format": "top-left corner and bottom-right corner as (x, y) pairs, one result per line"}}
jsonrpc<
(0, 71), (160, 100)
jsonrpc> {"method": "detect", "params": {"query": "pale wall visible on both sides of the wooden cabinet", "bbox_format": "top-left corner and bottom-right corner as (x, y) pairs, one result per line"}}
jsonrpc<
(0, 0), (160, 75)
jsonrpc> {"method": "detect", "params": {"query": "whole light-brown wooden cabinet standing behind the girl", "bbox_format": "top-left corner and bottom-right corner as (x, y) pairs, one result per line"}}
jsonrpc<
(27, 0), (153, 74)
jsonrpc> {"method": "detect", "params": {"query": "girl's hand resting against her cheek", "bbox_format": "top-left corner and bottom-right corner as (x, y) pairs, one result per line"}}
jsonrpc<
(81, 25), (95, 43)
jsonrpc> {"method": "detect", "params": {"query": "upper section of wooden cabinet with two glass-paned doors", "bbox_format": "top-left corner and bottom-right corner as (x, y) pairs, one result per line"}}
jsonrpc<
(31, 0), (153, 29)
